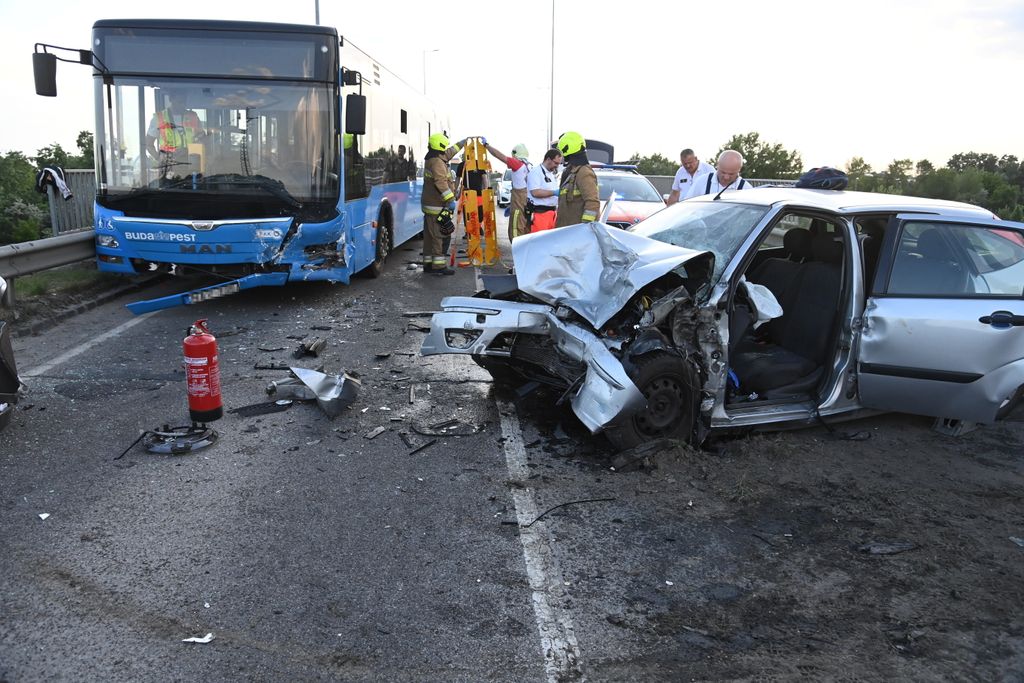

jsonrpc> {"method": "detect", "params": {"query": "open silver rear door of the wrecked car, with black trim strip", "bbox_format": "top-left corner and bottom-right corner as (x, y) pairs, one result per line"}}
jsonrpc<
(858, 214), (1024, 422)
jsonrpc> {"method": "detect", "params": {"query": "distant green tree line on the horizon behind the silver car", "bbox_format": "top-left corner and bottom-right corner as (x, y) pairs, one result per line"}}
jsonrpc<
(629, 132), (1024, 221)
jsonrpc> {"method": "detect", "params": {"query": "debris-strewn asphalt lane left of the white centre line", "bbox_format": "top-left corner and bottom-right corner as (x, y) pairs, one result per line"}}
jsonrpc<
(0, 220), (598, 681)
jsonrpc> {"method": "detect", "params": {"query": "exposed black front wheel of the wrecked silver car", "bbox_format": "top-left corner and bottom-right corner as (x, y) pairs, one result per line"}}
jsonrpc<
(605, 351), (697, 450)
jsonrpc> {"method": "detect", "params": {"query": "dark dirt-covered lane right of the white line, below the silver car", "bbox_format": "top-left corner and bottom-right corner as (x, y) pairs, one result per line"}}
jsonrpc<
(512, 393), (1024, 681)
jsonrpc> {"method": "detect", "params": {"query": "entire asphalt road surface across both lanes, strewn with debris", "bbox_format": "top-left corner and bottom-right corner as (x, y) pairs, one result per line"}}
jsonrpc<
(0, 216), (1024, 683)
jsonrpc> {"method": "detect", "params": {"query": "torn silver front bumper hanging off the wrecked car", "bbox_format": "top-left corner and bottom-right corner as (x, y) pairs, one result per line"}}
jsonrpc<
(420, 297), (646, 433)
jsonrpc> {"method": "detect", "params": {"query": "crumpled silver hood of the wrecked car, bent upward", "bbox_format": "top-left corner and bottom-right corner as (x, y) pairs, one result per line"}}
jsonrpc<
(512, 222), (714, 328)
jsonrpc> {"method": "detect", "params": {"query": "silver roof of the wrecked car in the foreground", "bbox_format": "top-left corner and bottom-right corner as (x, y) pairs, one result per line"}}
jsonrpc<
(687, 186), (993, 218)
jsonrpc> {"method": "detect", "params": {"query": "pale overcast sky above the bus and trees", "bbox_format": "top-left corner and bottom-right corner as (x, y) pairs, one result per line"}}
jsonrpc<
(0, 0), (1024, 174)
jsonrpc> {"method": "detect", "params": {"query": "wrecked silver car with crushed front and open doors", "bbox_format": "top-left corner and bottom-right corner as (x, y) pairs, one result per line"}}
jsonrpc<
(422, 187), (1024, 447)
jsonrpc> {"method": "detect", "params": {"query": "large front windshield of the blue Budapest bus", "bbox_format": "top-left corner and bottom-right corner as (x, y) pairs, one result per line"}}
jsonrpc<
(96, 77), (339, 220)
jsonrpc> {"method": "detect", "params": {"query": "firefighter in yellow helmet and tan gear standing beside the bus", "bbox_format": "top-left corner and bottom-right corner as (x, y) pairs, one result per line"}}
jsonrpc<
(421, 133), (466, 275)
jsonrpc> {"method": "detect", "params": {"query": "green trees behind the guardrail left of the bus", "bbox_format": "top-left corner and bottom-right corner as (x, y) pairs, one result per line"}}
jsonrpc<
(0, 130), (93, 245)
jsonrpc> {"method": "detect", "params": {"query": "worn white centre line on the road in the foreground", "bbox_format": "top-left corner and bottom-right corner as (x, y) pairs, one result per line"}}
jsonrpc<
(495, 400), (586, 683)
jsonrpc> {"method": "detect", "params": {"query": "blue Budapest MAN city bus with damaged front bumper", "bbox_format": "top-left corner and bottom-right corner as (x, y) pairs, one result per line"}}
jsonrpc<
(48, 19), (447, 313)
